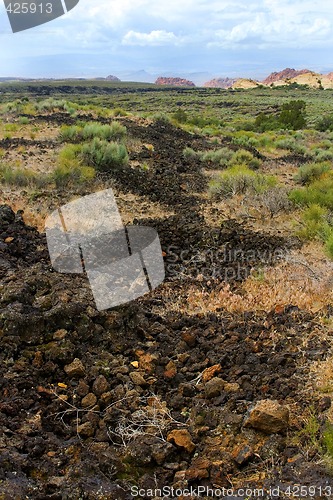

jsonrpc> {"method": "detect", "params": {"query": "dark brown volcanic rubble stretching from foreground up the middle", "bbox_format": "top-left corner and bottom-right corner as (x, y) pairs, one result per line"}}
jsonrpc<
(0, 116), (331, 500)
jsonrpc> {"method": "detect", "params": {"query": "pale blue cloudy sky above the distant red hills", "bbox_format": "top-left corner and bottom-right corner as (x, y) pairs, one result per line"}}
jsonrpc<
(0, 0), (333, 81)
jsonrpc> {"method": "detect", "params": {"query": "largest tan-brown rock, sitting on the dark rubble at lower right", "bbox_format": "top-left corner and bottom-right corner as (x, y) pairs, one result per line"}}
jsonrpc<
(244, 399), (289, 434)
